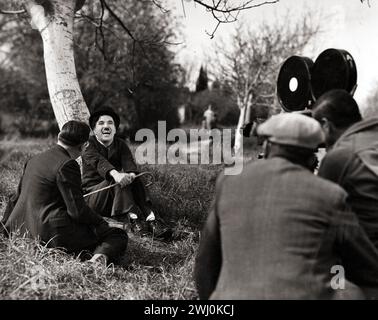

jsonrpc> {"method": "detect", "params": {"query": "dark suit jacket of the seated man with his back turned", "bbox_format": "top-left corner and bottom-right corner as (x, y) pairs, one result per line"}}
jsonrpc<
(2, 145), (107, 251)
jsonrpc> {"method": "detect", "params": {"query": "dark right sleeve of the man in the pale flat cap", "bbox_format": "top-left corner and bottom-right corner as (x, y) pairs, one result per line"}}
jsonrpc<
(334, 192), (378, 287)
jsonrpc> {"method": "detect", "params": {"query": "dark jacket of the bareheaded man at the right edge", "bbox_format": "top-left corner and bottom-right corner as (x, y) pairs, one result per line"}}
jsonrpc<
(318, 118), (378, 248)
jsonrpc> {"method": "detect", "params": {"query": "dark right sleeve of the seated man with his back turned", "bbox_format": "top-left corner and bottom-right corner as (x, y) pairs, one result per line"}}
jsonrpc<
(57, 160), (104, 225)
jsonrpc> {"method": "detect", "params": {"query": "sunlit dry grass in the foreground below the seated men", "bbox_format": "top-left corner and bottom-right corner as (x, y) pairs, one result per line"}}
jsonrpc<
(0, 230), (196, 300)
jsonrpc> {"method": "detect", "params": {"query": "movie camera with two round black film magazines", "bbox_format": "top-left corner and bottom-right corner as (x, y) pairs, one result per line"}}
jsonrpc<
(242, 48), (357, 137)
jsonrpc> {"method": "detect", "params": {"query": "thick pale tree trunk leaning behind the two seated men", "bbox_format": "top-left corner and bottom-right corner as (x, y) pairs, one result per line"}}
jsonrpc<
(23, 0), (89, 128)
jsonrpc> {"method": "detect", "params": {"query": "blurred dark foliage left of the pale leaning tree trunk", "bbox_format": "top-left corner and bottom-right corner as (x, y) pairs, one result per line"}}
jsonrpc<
(0, 1), (57, 135)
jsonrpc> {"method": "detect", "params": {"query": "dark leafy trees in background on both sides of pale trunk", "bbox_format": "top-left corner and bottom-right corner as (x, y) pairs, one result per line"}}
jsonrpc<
(0, 1), (183, 133)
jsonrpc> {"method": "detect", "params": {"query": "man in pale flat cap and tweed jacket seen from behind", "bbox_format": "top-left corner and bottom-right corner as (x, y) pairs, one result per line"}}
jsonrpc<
(195, 113), (378, 299)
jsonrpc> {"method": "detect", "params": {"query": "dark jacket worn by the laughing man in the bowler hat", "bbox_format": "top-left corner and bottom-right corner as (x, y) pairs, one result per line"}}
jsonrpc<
(82, 136), (138, 189)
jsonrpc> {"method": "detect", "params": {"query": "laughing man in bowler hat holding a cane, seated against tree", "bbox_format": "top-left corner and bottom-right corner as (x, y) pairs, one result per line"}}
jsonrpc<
(82, 107), (155, 230)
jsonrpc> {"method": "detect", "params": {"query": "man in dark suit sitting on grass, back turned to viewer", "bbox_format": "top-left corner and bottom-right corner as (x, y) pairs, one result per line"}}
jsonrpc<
(1, 121), (128, 263)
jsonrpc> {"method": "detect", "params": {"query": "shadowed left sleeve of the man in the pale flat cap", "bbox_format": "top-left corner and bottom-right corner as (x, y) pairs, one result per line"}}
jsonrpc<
(194, 174), (222, 300)
